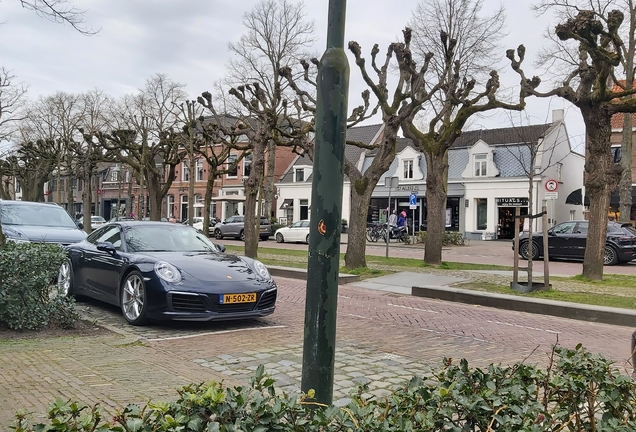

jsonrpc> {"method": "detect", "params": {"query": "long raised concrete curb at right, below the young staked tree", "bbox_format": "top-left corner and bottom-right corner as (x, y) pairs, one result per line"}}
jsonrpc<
(411, 286), (636, 327)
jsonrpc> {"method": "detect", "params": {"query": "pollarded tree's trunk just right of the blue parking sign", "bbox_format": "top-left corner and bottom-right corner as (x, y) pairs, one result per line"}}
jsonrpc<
(424, 151), (448, 265)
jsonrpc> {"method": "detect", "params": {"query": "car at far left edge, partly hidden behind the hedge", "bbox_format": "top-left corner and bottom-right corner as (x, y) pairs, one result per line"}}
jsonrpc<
(0, 200), (86, 245)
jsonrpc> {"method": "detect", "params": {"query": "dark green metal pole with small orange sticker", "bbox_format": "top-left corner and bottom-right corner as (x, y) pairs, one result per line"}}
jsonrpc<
(301, 0), (349, 405)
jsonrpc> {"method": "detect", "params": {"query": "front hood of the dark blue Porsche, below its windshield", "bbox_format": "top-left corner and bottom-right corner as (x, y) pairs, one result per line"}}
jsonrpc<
(144, 252), (261, 284)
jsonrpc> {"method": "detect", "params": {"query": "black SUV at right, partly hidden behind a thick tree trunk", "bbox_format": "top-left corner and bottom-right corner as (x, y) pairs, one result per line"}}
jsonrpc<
(512, 220), (636, 265)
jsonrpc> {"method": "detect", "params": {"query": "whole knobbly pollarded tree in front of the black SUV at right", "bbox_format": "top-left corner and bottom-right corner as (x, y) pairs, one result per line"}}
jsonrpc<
(508, 5), (636, 280)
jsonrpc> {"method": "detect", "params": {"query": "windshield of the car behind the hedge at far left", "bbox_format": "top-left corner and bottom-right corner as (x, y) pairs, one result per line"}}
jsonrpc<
(1, 203), (77, 228)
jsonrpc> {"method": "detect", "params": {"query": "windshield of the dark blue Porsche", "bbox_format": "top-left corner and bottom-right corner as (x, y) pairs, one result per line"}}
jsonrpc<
(124, 224), (220, 252)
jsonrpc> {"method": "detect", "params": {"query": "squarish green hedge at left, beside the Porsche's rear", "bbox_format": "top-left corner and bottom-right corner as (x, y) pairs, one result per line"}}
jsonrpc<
(0, 242), (79, 330)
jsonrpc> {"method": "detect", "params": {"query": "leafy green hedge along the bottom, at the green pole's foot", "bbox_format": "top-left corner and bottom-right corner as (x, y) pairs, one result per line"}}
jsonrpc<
(12, 346), (636, 432)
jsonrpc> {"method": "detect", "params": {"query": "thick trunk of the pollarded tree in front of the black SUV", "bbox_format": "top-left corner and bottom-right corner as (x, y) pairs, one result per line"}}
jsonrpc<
(581, 107), (622, 280)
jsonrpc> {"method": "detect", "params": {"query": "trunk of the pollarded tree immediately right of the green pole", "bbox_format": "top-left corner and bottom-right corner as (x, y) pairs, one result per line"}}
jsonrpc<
(345, 176), (378, 269)
